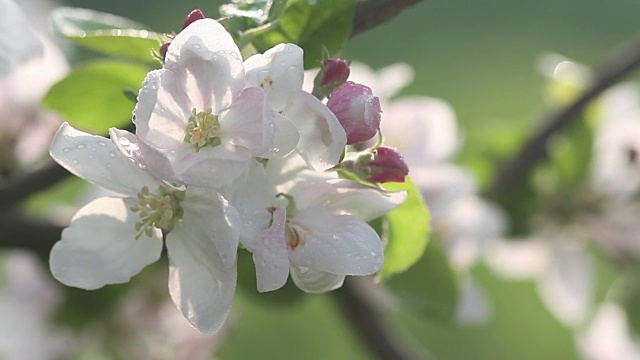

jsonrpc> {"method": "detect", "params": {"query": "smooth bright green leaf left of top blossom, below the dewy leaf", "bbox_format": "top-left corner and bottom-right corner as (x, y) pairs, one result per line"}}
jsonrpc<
(44, 61), (147, 134)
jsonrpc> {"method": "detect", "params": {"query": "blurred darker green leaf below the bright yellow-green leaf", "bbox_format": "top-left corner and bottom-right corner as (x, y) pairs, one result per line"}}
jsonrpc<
(385, 242), (458, 321)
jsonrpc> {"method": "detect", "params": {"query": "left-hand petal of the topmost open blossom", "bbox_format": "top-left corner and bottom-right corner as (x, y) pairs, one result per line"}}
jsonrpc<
(133, 69), (192, 149)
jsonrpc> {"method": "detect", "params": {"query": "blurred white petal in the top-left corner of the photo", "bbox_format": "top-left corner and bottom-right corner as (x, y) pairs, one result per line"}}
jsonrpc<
(0, 0), (42, 75)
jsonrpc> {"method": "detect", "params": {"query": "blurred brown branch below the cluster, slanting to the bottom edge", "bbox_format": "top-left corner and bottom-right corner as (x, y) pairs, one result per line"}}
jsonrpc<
(333, 277), (428, 360)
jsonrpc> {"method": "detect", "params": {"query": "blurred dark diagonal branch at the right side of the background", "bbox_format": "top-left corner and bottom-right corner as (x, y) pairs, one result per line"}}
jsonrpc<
(489, 36), (640, 198)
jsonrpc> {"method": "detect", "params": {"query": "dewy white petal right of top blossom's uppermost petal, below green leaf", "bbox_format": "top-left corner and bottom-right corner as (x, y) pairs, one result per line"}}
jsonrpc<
(244, 44), (304, 111)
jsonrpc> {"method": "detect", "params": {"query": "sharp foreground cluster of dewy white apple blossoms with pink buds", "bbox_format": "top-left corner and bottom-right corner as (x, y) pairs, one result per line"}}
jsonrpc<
(50, 11), (408, 333)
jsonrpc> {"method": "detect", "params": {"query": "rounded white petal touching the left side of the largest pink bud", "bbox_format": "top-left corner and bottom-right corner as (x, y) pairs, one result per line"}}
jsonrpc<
(282, 91), (347, 171)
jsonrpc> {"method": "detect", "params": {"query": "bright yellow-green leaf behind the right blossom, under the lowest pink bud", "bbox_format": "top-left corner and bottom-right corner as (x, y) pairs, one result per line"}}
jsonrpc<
(380, 177), (430, 279)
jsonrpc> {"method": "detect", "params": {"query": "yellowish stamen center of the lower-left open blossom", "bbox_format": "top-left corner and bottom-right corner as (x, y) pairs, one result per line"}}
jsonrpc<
(130, 186), (184, 240)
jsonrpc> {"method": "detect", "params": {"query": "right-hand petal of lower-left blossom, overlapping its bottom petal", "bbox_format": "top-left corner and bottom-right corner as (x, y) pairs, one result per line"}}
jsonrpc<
(180, 187), (240, 268)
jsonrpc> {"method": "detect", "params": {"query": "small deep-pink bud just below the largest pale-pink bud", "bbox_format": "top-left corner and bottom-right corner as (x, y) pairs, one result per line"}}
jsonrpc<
(361, 146), (409, 183)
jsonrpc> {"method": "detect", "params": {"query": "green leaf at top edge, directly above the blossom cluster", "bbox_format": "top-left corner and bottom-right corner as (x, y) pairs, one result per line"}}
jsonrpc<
(248, 0), (356, 69)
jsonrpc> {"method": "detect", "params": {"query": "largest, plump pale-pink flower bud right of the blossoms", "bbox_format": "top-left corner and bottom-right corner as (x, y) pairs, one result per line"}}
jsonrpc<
(327, 82), (382, 145)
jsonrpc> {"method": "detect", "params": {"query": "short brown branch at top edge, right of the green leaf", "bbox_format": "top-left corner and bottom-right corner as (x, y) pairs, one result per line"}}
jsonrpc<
(351, 0), (421, 37)
